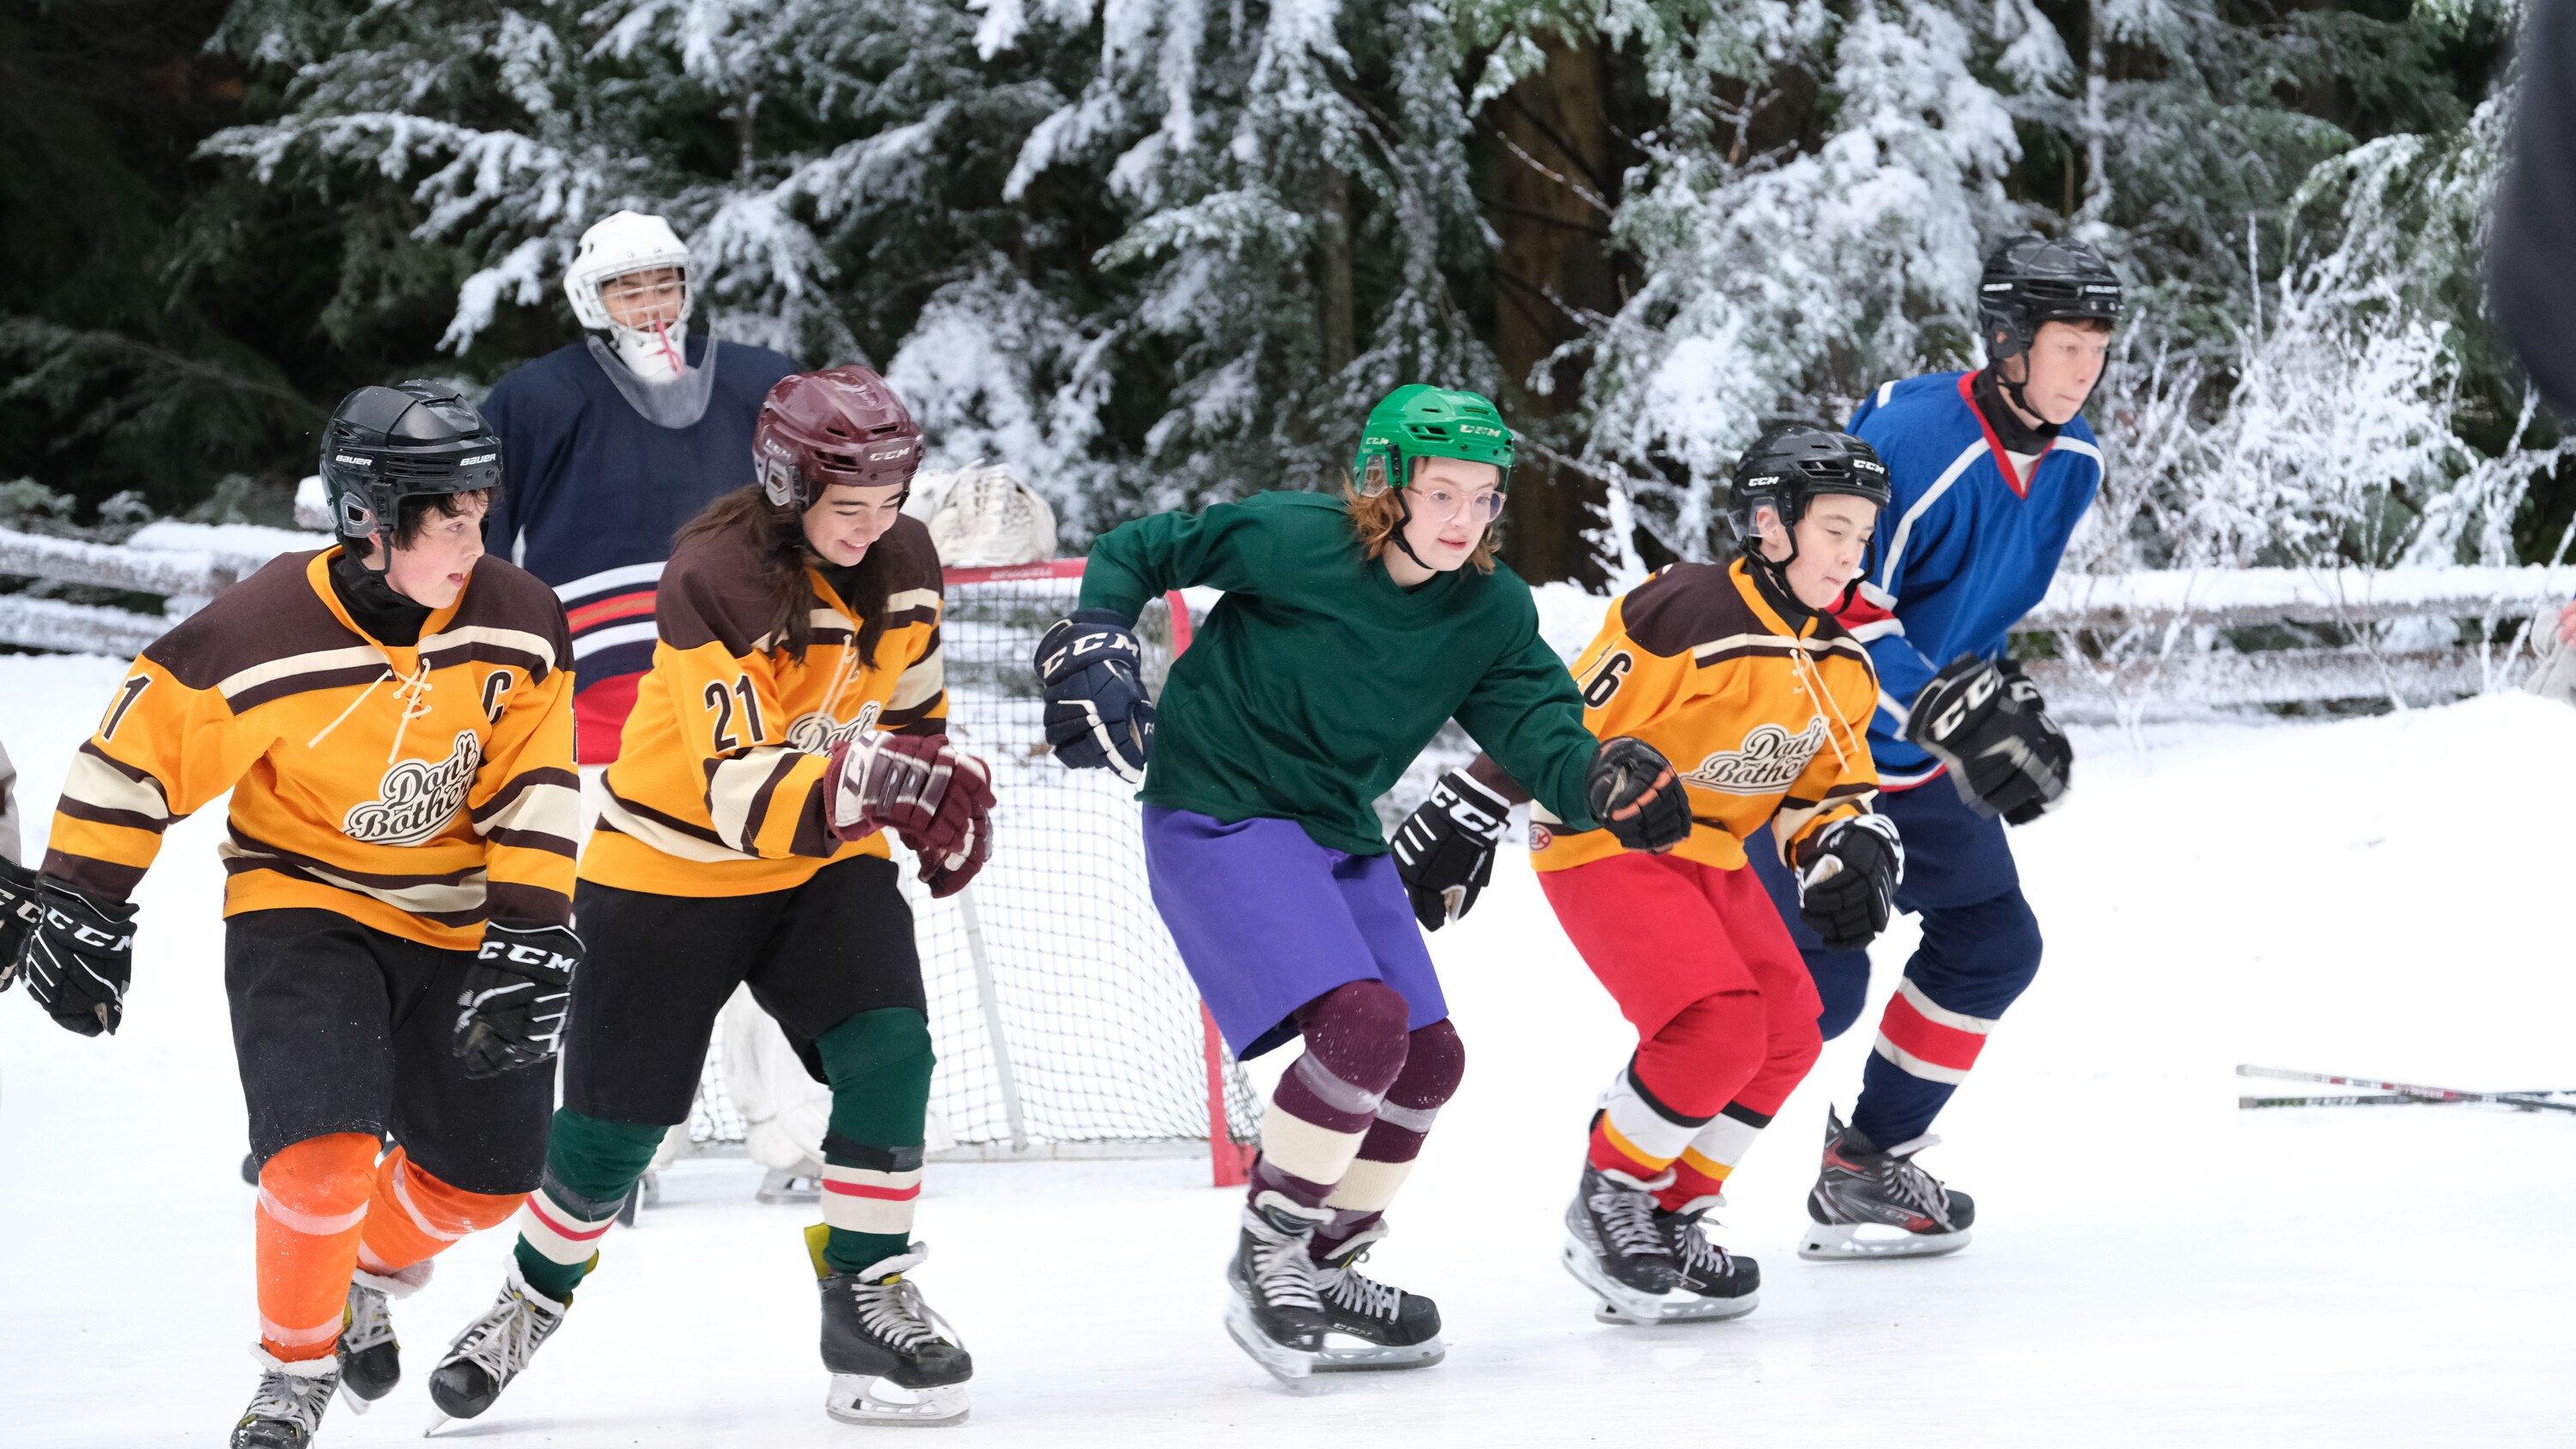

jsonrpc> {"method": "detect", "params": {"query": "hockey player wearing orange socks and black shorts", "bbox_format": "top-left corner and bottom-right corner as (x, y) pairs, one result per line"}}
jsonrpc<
(26, 384), (582, 1449)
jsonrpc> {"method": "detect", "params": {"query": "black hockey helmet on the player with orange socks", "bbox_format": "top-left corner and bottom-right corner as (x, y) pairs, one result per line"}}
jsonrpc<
(322, 381), (500, 541)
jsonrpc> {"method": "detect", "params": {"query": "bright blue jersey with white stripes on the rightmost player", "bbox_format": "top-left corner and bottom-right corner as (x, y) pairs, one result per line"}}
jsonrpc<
(1839, 373), (2102, 790)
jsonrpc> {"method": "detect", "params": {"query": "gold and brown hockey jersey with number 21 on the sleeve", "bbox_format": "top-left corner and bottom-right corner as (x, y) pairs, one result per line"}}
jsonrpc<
(582, 518), (948, 895)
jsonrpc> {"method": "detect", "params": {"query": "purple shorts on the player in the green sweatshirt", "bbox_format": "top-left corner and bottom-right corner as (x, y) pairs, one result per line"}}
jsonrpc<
(1144, 805), (1448, 1060)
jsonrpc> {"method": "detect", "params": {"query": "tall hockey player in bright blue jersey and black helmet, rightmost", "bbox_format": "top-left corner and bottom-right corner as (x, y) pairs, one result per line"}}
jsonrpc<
(1752, 237), (2120, 1258)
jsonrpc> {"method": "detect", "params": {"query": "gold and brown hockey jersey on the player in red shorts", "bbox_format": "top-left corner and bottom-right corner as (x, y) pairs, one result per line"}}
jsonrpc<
(1530, 559), (1878, 870)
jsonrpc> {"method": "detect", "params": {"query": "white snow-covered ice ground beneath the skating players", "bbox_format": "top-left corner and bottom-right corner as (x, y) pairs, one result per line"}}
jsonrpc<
(0, 657), (2576, 1449)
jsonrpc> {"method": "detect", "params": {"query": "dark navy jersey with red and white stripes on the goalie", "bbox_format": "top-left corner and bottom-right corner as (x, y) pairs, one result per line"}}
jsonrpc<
(482, 337), (801, 764)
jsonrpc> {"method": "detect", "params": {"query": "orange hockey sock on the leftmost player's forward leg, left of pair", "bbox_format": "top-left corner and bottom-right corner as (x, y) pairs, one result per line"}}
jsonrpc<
(255, 1132), (379, 1364)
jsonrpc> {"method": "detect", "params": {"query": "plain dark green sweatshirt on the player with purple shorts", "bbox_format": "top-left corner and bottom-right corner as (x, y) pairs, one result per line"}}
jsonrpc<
(1082, 494), (1600, 854)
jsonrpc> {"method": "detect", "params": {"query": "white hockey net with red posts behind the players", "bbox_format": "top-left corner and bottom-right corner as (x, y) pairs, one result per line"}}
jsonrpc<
(688, 559), (1260, 1181)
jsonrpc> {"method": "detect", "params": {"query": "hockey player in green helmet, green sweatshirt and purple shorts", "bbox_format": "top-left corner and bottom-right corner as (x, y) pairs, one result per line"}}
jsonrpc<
(1038, 384), (1690, 1379)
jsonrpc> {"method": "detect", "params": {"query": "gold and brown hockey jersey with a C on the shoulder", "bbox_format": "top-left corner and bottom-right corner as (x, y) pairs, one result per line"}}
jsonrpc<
(44, 549), (582, 949)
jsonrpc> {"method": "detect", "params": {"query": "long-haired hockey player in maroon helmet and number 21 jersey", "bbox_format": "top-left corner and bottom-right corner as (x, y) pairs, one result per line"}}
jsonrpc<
(430, 368), (992, 1423)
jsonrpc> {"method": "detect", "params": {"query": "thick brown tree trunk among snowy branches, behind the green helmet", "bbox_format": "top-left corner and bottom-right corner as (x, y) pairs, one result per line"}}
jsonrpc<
(1479, 36), (1620, 587)
